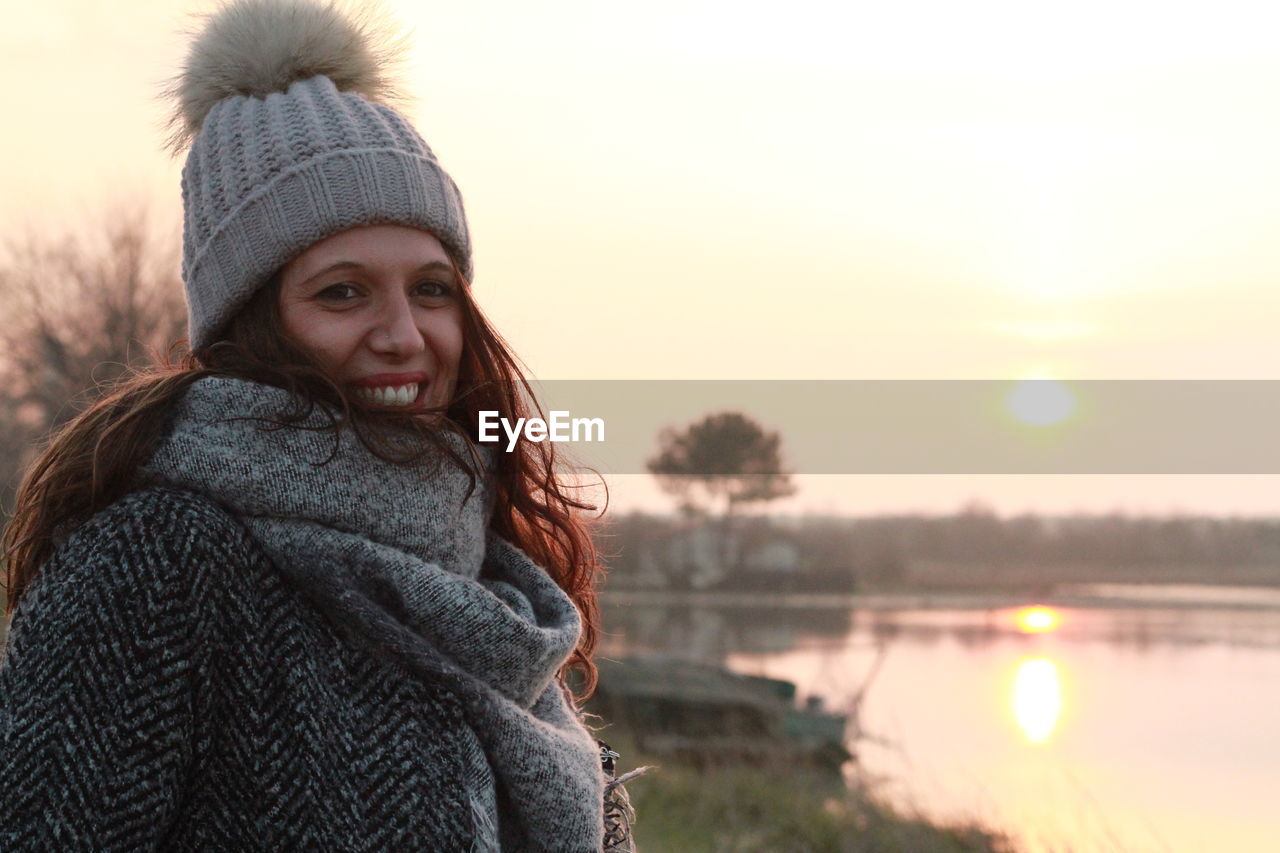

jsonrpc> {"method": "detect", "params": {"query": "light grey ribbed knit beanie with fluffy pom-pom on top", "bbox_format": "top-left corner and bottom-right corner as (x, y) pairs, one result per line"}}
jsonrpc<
(170, 0), (472, 350)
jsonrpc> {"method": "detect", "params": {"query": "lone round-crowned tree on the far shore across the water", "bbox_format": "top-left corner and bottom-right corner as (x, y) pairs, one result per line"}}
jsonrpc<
(648, 411), (795, 569)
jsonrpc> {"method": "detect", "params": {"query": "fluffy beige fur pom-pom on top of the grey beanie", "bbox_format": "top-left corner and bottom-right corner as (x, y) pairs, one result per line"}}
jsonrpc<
(165, 0), (403, 152)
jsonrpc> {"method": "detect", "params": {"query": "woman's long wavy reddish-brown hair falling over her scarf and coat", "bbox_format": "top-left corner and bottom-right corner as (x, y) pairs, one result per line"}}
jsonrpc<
(0, 266), (602, 698)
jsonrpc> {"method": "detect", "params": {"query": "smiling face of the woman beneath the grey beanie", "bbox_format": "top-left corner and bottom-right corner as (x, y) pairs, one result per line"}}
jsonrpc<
(280, 225), (462, 410)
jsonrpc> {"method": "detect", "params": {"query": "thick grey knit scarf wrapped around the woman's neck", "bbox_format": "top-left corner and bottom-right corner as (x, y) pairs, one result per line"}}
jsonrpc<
(142, 377), (604, 852)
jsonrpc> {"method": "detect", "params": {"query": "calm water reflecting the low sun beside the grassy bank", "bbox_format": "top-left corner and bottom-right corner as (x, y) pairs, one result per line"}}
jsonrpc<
(603, 589), (1280, 853)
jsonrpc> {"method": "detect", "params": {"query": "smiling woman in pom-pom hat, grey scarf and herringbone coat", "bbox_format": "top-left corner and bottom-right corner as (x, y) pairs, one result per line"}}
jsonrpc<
(0, 0), (634, 850)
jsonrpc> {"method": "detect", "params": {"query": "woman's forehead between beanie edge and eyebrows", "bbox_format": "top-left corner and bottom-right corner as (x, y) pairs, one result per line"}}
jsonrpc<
(283, 225), (449, 284)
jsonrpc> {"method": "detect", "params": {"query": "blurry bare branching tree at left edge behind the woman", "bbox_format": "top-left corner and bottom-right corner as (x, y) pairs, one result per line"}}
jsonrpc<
(0, 210), (186, 512)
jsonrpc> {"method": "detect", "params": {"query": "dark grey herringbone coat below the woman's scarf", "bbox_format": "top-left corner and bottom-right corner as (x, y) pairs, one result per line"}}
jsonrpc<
(0, 488), (481, 852)
